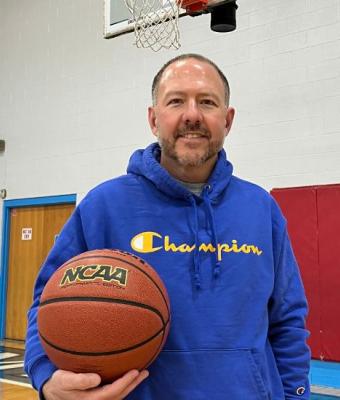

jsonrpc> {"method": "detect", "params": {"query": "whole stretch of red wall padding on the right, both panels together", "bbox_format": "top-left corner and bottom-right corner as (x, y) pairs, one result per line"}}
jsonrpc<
(271, 185), (340, 361)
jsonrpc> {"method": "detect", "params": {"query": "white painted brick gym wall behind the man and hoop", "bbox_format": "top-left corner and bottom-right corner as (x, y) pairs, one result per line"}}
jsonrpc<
(0, 0), (340, 244)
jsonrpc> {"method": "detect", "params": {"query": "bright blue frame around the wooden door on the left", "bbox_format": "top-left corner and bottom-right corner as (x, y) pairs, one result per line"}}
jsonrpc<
(0, 194), (77, 340)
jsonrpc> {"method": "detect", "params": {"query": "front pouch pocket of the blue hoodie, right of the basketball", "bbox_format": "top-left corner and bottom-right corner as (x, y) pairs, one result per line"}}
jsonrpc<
(136, 349), (270, 400)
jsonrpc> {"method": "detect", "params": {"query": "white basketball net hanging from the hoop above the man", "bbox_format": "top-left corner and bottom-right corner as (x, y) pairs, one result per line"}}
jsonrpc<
(125, 0), (182, 51)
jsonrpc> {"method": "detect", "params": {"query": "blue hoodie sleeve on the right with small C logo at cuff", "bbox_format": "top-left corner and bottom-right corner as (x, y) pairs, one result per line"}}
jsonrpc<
(268, 209), (310, 400)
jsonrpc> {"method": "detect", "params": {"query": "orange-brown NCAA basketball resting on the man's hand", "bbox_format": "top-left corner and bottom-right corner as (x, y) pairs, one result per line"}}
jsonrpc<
(38, 250), (170, 383)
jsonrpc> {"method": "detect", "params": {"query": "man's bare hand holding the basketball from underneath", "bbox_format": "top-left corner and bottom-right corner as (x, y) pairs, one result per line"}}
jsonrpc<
(43, 369), (149, 400)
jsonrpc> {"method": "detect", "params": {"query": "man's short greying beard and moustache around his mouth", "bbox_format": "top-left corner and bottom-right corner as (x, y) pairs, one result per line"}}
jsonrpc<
(158, 126), (223, 167)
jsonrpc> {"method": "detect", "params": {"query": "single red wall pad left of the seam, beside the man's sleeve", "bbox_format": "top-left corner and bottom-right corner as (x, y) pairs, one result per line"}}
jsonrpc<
(271, 187), (322, 358)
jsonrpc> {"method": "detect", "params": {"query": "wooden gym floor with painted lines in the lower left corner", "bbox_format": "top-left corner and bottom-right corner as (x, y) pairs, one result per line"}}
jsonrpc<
(0, 346), (39, 400)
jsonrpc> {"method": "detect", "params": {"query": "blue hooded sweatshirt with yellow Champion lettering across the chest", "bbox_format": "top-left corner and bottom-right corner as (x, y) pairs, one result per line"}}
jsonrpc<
(25, 144), (310, 400)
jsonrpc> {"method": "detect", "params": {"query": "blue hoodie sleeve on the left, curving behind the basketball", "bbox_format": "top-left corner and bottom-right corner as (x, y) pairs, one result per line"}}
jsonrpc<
(24, 208), (87, 398)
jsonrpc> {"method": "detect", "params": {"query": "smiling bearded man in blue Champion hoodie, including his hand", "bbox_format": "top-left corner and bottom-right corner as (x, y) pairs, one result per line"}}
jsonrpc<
(25, 54), (310, 400)
